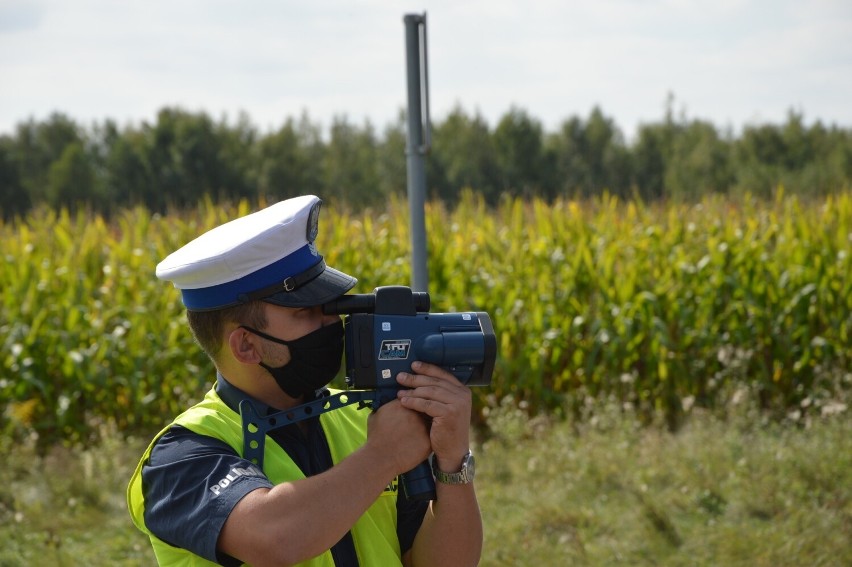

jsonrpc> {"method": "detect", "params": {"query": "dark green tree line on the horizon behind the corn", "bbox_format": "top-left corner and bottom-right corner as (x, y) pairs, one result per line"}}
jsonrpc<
(0, 97), (852, 218)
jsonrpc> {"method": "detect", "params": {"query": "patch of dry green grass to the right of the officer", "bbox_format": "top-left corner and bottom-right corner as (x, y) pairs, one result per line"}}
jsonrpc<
(478, 400), (852, 566)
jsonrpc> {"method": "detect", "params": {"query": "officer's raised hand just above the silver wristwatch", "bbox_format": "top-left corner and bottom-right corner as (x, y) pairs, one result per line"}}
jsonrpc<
(397, 362), (473, 471)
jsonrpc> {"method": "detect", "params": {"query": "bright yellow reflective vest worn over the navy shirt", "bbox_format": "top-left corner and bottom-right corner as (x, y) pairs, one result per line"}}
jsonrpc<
(127, 388), (402, 567)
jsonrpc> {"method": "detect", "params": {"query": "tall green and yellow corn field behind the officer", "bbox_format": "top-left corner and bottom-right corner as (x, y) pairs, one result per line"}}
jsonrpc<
(0, 191), (852, 443)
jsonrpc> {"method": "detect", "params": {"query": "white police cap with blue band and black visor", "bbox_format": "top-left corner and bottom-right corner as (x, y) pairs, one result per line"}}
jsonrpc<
(157, 195), (358, 311)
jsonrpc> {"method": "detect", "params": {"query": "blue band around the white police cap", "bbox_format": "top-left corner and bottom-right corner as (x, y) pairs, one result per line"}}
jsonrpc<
(180, 245), (322, 311)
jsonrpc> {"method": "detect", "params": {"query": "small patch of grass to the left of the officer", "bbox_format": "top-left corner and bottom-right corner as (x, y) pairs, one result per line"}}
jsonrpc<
(0, 432), (151, 567)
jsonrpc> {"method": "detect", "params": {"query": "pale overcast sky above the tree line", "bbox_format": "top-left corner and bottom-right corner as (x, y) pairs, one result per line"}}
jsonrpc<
(0, 0), (852, 139)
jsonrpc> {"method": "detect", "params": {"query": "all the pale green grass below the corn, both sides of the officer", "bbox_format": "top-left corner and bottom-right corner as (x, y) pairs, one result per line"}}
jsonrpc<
(0, 405), (852, 567)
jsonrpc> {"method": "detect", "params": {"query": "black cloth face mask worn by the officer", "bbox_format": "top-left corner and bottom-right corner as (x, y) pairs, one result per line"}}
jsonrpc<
(242, 321), (343, 398)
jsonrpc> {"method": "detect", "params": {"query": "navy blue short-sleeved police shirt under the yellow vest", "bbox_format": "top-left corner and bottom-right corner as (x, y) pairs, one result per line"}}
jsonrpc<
(142, 375), (428, 567)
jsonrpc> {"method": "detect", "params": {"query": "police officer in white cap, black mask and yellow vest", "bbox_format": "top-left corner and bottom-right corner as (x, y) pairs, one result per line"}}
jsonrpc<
(128, 196), (482, 567)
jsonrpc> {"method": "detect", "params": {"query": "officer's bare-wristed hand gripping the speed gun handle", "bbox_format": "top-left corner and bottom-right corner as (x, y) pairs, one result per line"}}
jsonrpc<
(367, 400), (432, 475)
